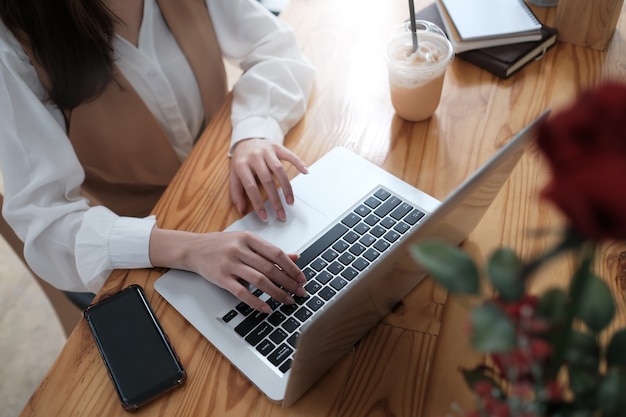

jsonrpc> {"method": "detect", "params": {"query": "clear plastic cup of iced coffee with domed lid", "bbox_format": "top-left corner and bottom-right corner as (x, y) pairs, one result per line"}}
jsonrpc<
(386, 20), (454, 122)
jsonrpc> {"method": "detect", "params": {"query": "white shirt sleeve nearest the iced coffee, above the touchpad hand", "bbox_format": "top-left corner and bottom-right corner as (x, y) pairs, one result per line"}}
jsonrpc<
(207, 0), (315, 149)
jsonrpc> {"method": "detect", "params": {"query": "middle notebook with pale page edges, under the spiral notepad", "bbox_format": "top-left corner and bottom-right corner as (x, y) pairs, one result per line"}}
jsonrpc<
(435, 0), (541, 54)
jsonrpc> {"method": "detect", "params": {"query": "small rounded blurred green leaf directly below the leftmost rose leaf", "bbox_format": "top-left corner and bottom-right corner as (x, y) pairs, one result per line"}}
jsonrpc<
(471, 302), (516, 352)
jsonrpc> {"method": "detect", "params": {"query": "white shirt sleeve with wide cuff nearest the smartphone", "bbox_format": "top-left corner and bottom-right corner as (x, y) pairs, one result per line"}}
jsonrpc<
(0, 25), (154, 292)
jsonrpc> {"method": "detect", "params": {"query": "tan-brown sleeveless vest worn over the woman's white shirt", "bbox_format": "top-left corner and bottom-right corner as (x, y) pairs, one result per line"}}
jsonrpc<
(34, 0), (227, 216)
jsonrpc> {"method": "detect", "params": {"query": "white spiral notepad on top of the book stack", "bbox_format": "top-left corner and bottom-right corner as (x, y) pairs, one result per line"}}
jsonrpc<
(440, 0), (541, 41)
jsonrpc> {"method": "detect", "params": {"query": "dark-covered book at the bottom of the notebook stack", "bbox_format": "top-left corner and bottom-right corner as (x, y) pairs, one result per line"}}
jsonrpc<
(415, 3), (557, 78)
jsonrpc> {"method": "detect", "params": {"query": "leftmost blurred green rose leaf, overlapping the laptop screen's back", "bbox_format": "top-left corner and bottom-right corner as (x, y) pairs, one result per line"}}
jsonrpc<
(411, 240), (480, 294)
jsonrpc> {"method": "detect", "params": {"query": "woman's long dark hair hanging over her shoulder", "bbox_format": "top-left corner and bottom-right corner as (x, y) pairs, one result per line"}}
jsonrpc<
(0, 0), (115, 110)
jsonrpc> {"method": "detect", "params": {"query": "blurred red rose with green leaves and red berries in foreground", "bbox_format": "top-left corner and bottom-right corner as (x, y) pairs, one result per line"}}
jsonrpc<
(411, 81), (626, 417)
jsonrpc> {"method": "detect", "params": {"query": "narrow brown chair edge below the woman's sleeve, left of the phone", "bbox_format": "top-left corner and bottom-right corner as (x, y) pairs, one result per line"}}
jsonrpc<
(0, 194), (94, 336)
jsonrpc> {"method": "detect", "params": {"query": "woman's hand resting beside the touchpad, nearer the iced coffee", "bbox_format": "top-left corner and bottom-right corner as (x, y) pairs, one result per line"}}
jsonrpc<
(230, 138), (308, 221)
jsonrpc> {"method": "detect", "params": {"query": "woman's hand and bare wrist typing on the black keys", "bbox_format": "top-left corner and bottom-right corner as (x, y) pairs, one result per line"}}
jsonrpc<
(150, 228), (306, 313)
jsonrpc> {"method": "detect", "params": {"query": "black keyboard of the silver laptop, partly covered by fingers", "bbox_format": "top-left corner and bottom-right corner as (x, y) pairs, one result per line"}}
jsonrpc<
(219, 187), (424, 373)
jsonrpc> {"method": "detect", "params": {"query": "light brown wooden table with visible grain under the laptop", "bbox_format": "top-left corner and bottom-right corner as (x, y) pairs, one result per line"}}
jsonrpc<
(21, 0), (626, 417)
